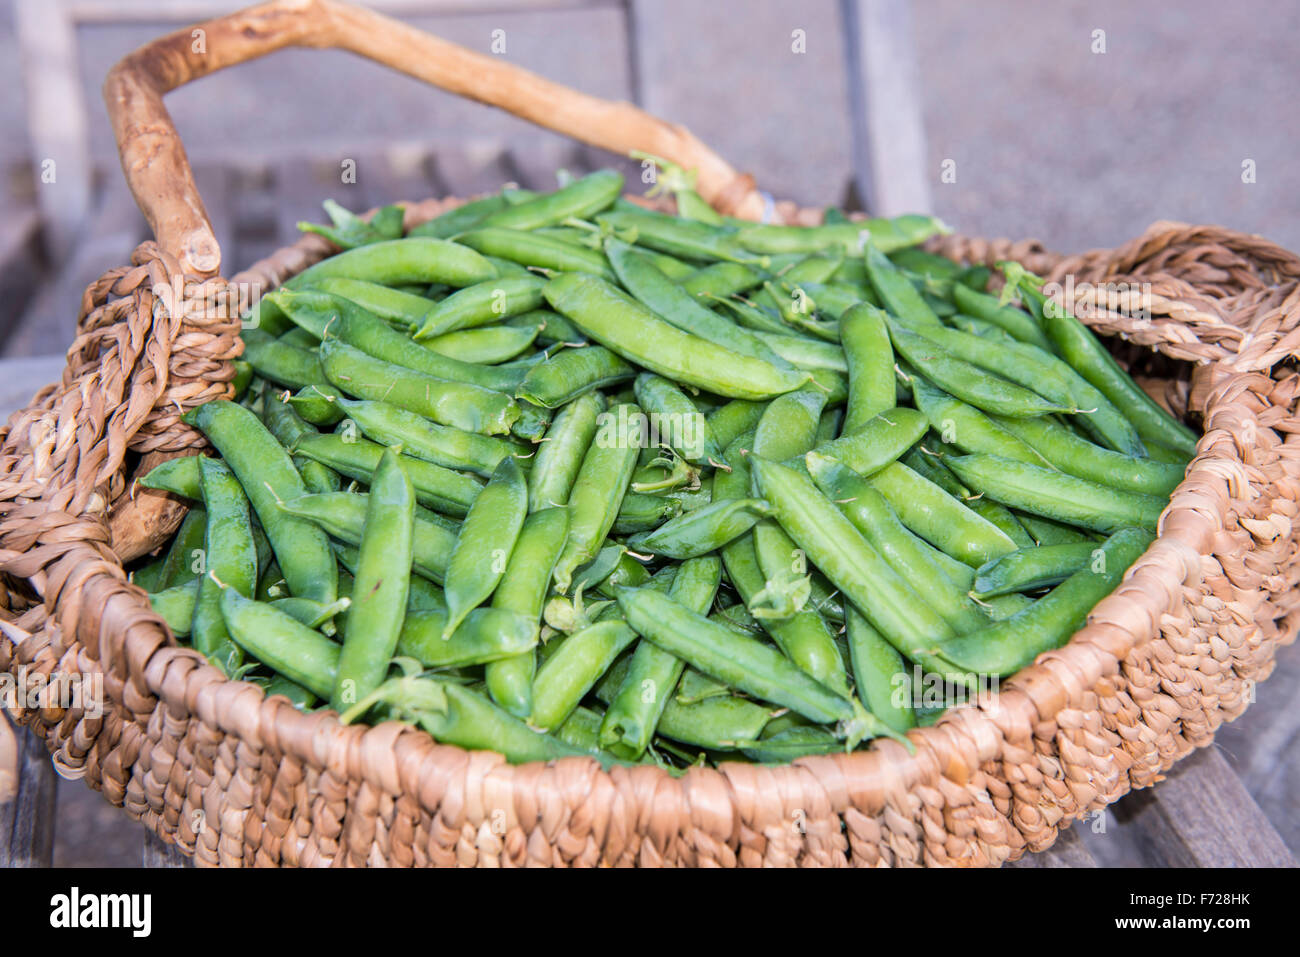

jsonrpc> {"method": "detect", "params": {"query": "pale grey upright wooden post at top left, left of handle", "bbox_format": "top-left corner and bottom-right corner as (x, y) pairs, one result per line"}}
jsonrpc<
(14, 0), (92, 260)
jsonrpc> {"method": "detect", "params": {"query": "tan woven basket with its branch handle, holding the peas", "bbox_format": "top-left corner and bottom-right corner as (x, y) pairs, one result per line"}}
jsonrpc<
(0, 0), (1300, 867)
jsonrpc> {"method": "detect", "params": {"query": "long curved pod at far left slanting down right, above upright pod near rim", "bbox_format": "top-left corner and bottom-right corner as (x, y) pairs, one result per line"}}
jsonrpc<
(185, 400), (335, 605)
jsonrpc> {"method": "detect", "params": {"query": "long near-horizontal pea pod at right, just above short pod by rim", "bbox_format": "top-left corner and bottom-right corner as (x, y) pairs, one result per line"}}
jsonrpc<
(946, 455), (1169, 533)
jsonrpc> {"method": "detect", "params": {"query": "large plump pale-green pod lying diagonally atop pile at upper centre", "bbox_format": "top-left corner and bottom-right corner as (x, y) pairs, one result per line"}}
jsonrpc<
(545, 273), (806, 399)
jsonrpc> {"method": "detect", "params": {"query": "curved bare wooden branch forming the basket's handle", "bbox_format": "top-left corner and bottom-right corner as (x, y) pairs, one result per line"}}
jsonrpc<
(104, 0), (762, 276)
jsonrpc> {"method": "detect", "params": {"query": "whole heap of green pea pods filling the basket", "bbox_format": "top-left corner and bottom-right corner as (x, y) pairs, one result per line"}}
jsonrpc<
(133, 165), (1196, 770)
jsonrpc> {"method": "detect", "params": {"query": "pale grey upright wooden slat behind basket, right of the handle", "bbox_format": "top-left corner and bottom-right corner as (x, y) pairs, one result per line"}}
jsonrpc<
(841, 0), (931, 216)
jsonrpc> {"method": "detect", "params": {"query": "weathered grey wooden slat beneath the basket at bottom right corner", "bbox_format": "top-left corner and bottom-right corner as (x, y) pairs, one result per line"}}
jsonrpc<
(1115, 748), (1296, 867)
